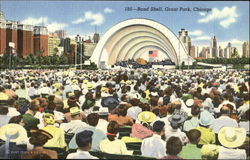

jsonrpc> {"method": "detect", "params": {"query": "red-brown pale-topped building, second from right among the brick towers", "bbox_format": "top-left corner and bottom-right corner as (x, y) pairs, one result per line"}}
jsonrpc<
(17, 24), (34, 57)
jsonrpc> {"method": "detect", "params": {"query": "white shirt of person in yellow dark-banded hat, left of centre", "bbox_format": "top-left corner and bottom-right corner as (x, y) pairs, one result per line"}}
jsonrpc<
(60, 120), (88, 133)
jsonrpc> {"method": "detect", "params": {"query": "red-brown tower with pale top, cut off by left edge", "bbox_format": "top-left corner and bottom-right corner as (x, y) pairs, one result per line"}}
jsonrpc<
(0, 11), (6, 55)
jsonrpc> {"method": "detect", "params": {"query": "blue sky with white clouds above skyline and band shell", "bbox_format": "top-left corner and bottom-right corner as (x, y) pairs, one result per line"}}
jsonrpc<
(1, 0), (249, 54)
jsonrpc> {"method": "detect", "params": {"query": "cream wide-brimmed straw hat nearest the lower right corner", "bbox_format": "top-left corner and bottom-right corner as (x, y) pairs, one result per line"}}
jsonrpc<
(218, 127), (246, 148)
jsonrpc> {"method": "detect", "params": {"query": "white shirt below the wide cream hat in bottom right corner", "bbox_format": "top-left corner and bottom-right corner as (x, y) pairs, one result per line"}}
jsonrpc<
(218, 146), (247, 159)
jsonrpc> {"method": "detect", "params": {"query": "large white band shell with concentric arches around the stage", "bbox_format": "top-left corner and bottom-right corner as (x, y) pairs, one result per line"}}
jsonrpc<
(90, 18), (195, 68)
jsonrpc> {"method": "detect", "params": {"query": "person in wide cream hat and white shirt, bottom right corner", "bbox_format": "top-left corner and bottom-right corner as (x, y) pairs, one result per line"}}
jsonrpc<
(218, 127), (247, 159)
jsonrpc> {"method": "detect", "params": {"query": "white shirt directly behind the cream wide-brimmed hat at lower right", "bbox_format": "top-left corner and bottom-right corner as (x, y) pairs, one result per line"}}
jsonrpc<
(210, 116), (238, 134)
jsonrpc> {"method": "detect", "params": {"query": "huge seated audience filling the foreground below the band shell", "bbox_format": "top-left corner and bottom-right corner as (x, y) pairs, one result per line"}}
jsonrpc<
(0, 69), (250, 160)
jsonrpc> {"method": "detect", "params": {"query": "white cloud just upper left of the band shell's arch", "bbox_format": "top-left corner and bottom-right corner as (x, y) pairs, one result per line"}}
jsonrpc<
(72, 11), (104, 25)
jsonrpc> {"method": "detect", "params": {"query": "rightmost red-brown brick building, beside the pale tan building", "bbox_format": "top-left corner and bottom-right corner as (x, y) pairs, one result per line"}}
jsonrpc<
(34, 26), (49, 56)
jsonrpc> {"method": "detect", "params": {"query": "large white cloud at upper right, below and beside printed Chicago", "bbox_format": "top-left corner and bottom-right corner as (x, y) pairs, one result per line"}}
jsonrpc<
(198, 6), (238, 28)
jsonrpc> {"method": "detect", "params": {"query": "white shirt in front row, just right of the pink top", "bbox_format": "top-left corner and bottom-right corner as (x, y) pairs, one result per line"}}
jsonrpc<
(141, 134), (166, 158)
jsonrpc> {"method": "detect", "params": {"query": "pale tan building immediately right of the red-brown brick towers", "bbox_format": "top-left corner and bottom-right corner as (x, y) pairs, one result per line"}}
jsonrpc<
(48, 33), (61, 56)
